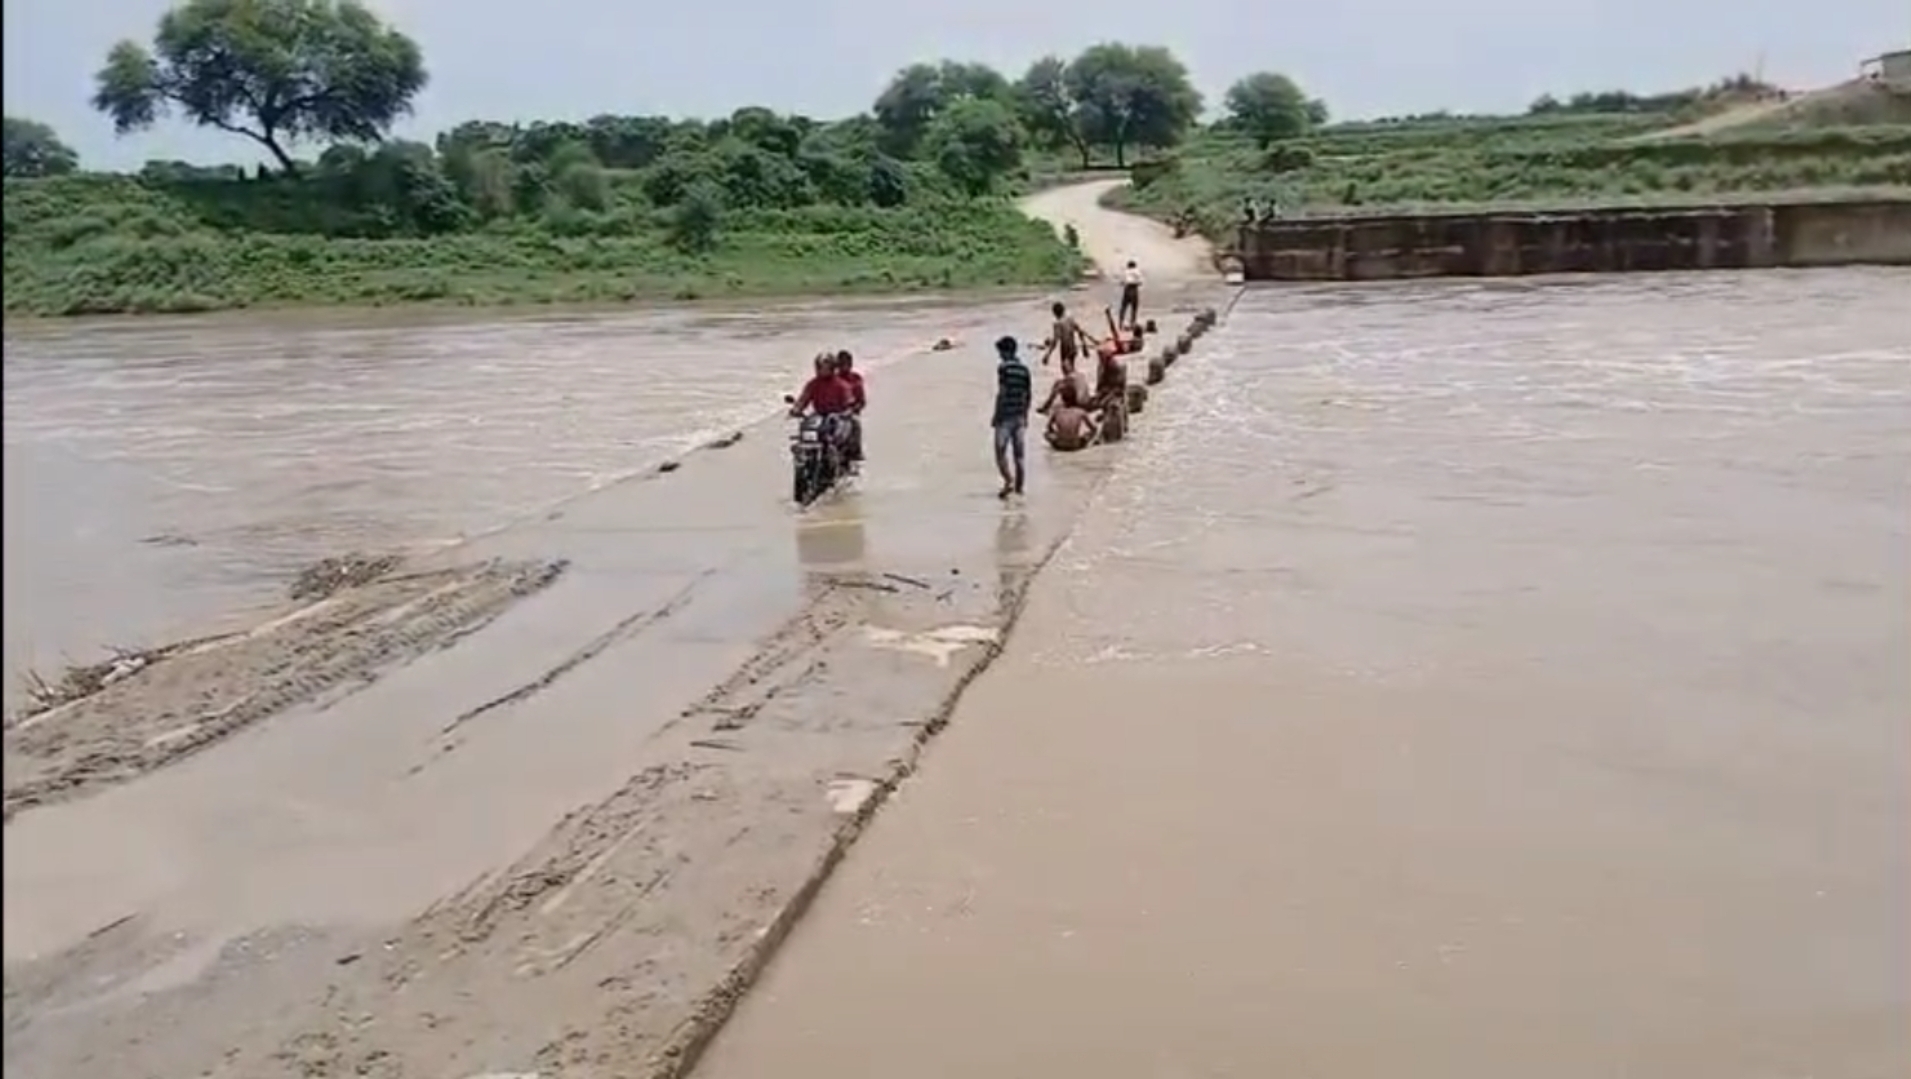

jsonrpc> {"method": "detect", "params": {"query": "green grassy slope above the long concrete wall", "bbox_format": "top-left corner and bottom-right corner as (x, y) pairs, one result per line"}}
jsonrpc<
(1114, 104), (1911, 239)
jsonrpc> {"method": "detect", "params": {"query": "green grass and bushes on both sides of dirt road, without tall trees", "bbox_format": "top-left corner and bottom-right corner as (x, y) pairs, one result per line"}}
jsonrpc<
(18, 77), (1911, 317)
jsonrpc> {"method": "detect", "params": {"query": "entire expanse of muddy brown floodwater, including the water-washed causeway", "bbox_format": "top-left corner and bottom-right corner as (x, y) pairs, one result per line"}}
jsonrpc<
(4, 263), (1911, 1079)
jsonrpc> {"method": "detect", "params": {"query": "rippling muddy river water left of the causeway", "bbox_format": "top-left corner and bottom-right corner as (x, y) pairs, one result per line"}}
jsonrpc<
(4, 294), (1040, 701)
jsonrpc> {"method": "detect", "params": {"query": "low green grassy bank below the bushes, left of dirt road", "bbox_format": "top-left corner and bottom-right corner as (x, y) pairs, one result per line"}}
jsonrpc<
(6, 176), (1078, 315)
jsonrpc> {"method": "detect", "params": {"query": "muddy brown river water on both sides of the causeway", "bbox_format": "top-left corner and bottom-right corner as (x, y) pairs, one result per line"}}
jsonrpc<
(6, 271), (1911, 1075)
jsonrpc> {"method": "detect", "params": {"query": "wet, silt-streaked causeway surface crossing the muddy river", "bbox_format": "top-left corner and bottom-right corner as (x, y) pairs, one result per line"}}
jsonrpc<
(4, 286), (1223, 1077)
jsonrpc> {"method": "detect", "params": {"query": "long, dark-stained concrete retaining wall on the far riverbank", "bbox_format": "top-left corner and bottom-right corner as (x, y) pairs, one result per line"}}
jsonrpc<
(1233, 199), (1911, 281)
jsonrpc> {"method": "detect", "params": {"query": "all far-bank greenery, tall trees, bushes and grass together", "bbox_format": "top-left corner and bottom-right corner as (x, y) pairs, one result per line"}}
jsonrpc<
(18, 0), (1911, 315)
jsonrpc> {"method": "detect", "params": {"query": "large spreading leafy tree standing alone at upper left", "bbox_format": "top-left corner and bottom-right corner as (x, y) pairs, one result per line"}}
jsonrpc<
(94, 0), (426, 172)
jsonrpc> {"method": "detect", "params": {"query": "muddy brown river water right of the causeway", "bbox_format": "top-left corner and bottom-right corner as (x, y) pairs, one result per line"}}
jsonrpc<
(699, 271), (1911, 1079)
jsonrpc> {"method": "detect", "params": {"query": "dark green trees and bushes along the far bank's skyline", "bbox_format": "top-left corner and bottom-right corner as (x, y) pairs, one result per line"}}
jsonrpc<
(6, 0), (1760, 237)
